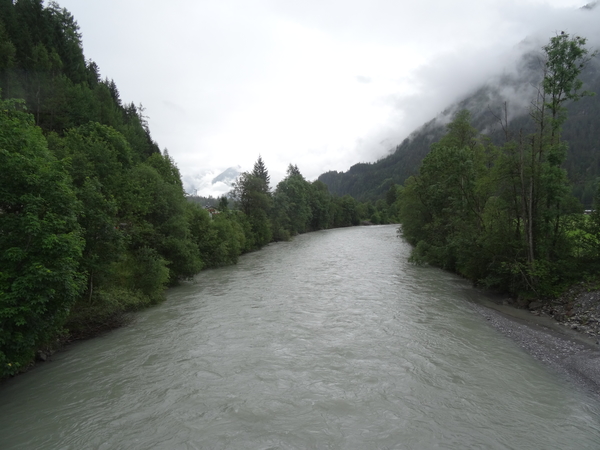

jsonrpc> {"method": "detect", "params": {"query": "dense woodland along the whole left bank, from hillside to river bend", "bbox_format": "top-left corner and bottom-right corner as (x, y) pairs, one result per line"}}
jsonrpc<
(0, 0), (398, 378)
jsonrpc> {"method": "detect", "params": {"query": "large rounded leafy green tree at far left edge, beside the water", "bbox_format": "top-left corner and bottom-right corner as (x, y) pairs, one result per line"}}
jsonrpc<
(0, 101), (84, 377)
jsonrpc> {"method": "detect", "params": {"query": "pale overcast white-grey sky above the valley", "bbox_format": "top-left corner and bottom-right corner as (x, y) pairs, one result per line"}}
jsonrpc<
(57, 0), (600, 196)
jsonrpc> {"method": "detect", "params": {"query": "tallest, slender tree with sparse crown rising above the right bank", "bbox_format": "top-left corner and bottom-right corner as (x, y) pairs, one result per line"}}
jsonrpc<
(517, 33), (590, 286)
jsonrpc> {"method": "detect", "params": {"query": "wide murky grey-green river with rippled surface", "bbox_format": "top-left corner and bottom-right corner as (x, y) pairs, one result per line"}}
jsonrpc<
(0, 226), (600, 450)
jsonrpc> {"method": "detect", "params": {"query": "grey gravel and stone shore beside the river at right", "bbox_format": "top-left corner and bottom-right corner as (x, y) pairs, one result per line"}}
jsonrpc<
(473, 283), (600, 400)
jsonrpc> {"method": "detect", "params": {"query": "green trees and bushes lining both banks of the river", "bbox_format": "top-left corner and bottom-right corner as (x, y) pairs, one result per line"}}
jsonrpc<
(0, 0), (600, 378)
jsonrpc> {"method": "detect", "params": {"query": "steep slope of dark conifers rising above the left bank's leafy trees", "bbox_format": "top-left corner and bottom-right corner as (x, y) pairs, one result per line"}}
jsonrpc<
(0, 0), (159, 157)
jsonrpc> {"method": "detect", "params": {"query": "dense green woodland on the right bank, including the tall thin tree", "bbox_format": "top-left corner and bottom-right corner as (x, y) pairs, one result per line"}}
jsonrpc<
(397, 34), (600, 299)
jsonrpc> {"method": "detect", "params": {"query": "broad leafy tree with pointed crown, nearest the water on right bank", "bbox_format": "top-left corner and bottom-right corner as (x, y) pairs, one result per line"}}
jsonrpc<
(400, 111), (488, 276)
